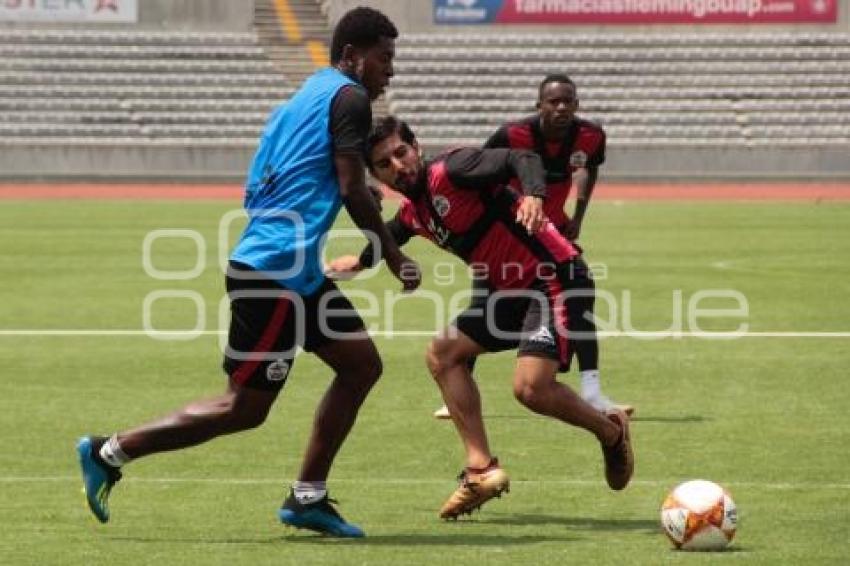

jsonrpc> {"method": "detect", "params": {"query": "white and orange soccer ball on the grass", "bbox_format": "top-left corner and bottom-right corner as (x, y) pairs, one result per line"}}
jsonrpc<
(661, 480), (738, 550)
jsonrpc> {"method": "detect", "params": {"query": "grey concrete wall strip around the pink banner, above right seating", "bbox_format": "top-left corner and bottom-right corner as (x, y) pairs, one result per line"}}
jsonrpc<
(328, 0), (850, 34)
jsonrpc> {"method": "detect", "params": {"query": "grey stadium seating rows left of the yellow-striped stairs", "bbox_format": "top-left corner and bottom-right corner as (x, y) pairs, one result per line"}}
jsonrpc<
(0, 28), (293, 148)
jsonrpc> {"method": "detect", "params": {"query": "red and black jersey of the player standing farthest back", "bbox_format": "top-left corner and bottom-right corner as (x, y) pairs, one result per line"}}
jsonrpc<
(484, 114), (605, 226)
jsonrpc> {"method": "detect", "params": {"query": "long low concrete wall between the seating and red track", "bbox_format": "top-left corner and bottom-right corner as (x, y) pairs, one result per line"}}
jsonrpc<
(0, 144), (850, 183)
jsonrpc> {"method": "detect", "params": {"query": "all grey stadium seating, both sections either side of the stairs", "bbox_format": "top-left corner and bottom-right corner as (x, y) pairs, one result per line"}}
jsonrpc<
(0, 4), (850, 175)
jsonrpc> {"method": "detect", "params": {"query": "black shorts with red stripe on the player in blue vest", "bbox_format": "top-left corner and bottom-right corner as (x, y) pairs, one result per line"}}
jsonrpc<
(223, 262), (364, 391)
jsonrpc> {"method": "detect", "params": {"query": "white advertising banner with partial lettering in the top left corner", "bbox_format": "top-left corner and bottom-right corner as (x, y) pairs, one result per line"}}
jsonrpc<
(0, 0), (139, 23)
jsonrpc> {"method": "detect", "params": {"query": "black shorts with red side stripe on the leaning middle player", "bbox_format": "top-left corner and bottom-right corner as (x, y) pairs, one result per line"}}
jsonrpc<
(453, 259), (595, 372)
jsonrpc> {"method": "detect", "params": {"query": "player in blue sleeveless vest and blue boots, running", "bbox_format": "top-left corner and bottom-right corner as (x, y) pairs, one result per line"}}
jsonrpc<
(77, 8), (420, 537)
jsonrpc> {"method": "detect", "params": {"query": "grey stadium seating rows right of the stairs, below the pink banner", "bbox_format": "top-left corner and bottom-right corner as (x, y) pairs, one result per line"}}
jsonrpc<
(388, 32), (850, 153)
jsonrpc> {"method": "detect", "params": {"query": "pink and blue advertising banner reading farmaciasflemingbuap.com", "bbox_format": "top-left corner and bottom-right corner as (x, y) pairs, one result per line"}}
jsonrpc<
(434, 0), (838, 25)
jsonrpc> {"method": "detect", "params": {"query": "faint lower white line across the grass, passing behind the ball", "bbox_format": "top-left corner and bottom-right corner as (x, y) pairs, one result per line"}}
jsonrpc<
(0, 476), (850, 491)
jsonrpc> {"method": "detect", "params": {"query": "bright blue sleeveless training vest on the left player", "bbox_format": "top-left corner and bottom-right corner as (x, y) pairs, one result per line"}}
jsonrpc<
(230, 68), (357, 295)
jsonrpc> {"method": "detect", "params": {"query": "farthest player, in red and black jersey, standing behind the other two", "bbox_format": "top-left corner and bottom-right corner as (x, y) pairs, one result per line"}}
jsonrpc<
(434, 75), (634, 419)
